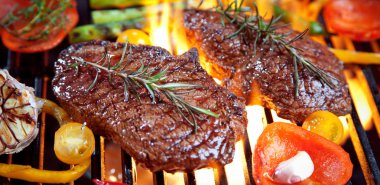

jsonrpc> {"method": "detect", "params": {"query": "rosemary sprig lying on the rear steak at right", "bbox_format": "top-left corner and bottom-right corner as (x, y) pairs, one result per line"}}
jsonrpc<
(208, 0), (335, 97)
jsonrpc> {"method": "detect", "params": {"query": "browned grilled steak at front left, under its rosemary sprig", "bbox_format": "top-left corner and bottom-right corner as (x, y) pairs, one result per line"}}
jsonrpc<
(53, 41), (246, 171)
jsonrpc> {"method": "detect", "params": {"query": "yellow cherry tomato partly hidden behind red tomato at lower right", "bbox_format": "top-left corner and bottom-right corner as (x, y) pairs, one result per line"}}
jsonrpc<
(302, 111), (344, 144)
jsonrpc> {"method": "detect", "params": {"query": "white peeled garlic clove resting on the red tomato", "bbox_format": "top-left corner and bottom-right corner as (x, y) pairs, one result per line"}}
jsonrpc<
(272, 151), (314, 184)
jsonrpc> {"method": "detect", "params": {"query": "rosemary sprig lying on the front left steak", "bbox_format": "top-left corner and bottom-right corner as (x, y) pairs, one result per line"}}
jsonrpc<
(69, 43), (219, 132)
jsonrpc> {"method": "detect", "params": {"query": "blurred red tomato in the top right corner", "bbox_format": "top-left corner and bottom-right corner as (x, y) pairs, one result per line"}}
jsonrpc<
(324, 0), (380, 41)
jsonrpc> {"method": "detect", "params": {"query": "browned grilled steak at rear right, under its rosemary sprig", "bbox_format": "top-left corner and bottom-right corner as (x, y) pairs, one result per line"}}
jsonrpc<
(184, 10), (351, 121)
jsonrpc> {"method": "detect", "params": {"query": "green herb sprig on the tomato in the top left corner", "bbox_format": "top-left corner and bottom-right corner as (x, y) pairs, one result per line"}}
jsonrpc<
(0, 0), (72, 40)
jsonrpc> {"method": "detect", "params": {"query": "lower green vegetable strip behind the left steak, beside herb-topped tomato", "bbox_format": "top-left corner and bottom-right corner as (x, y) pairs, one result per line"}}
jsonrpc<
(69, 18), (144, 43)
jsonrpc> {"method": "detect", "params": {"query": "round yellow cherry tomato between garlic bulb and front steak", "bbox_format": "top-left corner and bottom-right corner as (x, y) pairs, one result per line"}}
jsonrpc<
(54, 122), (95, 164)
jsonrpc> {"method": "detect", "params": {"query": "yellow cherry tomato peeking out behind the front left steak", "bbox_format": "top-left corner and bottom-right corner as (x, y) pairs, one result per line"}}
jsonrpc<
(116, 29), (151, 45)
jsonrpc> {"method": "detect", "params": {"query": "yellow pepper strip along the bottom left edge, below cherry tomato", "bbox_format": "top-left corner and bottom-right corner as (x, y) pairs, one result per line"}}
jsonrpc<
(0, 158), (91, 183)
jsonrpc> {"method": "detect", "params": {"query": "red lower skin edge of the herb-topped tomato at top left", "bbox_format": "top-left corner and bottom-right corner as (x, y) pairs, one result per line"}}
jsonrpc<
(2, 0), (79, 53)
